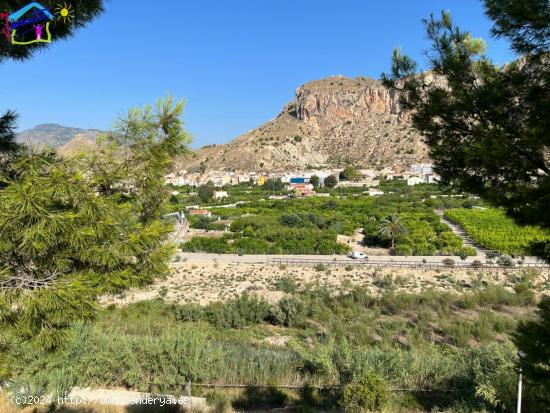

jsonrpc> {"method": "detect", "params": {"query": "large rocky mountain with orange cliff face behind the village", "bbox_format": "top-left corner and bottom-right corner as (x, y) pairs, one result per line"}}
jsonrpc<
(178, 76), (428, 172)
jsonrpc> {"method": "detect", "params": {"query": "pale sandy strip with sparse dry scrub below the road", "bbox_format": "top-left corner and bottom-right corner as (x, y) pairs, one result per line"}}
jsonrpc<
(101, 262), (550, 305)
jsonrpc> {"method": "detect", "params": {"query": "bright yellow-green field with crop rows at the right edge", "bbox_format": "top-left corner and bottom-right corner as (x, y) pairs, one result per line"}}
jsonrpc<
(445, 208), (550, 255)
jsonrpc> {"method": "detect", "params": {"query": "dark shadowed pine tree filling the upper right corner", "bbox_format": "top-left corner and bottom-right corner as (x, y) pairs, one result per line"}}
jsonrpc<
(383, 0), (550, 260)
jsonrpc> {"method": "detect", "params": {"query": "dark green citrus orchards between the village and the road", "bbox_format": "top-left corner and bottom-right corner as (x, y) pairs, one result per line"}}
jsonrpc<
(174, 183), (475, 255)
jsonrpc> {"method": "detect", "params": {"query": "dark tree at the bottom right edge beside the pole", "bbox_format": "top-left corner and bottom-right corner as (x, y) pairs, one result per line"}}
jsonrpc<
(514, 297), (550, 411)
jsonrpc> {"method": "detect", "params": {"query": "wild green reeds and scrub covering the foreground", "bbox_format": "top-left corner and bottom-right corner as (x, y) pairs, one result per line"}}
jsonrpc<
(6, 272), (535, 412)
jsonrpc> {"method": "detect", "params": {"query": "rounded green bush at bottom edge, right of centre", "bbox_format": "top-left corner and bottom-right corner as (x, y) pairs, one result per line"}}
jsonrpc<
(340, 372), (390, 412)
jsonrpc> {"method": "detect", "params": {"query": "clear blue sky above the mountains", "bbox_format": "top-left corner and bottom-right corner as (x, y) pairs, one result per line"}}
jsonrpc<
(0, 0), (513, 147)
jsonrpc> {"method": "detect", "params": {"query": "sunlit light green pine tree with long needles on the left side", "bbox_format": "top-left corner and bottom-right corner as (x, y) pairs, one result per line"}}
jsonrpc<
(0, 99), (189, 376)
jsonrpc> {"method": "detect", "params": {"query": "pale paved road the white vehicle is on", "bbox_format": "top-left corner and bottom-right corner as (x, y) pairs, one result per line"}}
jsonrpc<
(179, 252), (539, 264)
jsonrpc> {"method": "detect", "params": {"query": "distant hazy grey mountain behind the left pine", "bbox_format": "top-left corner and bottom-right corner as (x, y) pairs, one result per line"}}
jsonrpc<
(17, 123), (101, 149)
